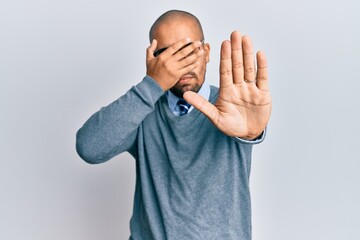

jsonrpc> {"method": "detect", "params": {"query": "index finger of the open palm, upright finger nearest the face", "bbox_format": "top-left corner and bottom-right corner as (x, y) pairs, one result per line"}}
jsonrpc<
(220, 40), (233, 90)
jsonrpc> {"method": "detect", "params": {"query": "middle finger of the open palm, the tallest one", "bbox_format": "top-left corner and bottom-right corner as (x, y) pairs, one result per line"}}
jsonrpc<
(230, 31), (244, 83)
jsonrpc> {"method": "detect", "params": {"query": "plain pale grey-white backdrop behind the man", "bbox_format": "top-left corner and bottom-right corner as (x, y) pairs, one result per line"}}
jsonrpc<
(0, 0), (360, 240)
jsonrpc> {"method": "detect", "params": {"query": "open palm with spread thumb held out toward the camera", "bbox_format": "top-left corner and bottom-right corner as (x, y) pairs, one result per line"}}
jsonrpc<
(184, 31), (272, 139)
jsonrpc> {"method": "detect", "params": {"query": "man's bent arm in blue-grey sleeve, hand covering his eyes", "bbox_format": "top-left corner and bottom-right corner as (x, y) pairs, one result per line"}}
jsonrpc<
(76, 38), (202, 163)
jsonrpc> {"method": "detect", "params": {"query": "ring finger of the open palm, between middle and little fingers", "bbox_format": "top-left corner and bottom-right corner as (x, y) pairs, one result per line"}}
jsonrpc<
(242, 36), (256, 82)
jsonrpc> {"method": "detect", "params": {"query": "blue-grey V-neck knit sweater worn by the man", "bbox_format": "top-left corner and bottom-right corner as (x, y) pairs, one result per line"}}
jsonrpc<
(76, 77), (262, 240)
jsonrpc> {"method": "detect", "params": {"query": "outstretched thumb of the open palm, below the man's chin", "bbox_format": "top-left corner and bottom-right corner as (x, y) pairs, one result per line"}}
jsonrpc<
(183, 91), (219, 124)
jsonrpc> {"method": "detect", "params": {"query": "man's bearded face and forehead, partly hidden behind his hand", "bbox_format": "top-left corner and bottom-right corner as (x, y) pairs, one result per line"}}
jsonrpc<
(154, 19), (210, 98)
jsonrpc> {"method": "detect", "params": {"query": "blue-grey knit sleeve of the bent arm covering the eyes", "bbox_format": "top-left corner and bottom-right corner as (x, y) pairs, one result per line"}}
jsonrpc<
(76, 76), (164, 164)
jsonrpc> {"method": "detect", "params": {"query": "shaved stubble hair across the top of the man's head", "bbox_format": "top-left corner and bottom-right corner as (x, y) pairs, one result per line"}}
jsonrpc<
(149, 10), (204, 42)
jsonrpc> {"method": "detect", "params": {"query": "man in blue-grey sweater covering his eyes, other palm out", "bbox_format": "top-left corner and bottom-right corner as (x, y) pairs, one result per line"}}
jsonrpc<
(76, 10), (271, 240)
